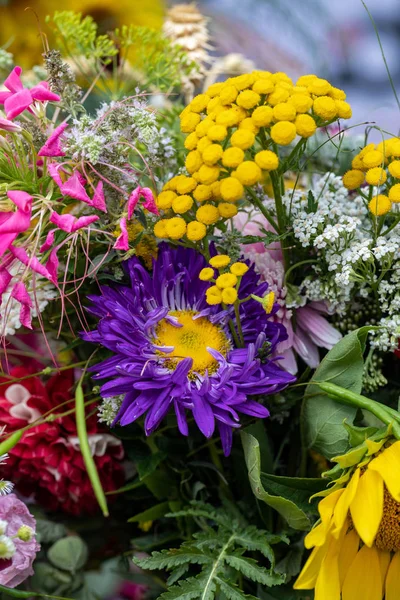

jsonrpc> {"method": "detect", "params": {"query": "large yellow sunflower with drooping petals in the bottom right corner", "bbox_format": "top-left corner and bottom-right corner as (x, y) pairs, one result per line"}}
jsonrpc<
(294, 439), (400, 600)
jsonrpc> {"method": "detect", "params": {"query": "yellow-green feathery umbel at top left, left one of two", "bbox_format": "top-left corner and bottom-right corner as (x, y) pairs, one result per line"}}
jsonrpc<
(47, 10), (118, 64)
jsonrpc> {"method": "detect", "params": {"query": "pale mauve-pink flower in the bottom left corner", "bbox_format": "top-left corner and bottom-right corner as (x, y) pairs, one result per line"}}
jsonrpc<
(0, 494), (40, 588)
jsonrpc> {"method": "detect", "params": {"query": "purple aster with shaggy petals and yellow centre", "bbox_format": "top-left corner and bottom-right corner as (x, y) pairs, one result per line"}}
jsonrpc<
(83, 244), (294, 455)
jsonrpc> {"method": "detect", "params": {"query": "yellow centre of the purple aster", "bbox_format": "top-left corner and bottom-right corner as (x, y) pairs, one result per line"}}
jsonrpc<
(153, 310), (229, 375)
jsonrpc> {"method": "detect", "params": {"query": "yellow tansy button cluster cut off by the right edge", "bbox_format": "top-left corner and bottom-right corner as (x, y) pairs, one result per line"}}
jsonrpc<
(343, 138), (400, 217)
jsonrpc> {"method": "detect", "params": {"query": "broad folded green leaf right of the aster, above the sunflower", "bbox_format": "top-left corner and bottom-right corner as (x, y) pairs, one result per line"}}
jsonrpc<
(302, 327), (374, 459)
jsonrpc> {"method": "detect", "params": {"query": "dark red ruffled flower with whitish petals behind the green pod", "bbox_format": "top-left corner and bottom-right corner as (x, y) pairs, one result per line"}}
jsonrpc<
(0, 367), (124, 515)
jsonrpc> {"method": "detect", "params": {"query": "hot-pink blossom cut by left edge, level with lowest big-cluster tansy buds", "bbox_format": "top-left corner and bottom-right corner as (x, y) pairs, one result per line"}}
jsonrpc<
(0, 191), (32, 256)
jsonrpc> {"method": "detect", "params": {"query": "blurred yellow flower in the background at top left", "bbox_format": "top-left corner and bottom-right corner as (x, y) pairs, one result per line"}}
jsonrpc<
(0, 0), (164, 68)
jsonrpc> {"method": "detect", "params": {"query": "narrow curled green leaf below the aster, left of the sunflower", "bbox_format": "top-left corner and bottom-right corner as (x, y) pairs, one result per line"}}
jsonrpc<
(241, 431), (311, 531)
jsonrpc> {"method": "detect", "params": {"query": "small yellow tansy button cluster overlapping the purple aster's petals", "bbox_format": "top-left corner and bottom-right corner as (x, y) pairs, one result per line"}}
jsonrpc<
(199, 254), (249, 305)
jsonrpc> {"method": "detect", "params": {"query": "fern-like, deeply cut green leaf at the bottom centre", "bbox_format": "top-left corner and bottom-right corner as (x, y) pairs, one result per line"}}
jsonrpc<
(134, 501), (287, 600)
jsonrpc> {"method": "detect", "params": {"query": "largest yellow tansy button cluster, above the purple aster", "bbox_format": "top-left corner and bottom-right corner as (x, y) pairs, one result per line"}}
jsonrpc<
(154, 71), (351, 242)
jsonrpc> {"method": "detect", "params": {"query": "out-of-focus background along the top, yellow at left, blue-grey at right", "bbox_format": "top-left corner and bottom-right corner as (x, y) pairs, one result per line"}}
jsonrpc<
(0, 0), (400, 133)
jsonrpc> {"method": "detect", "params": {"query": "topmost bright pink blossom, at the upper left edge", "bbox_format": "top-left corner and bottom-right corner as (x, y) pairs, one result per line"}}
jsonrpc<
(0, 67), (60, 119)
